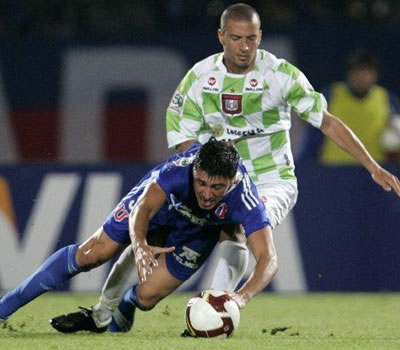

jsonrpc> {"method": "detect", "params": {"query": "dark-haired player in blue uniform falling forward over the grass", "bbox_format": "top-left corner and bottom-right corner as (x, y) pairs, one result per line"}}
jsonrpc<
(0, 139), (277, 331)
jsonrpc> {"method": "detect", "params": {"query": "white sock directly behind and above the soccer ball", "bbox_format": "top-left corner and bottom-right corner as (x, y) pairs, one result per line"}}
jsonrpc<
(210, 241), (249, 291)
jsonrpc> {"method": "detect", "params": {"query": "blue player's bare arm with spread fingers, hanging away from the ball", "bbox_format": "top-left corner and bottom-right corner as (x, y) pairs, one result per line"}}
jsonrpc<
(129, 182), (175, 284)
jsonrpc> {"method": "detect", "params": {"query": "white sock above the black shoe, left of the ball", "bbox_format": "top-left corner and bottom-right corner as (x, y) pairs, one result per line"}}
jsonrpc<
(92, 246), (138, 328)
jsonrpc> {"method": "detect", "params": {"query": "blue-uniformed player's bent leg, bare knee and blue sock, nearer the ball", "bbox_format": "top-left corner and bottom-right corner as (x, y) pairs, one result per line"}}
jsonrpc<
(109, 254), (183, 332)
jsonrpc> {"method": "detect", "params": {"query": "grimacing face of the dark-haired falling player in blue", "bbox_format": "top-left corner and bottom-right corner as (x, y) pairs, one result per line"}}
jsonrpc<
(193, 168), (232, 210)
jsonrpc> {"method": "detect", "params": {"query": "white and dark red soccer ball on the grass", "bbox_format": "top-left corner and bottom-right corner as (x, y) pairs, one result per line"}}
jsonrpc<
(185, 290), (240, 338)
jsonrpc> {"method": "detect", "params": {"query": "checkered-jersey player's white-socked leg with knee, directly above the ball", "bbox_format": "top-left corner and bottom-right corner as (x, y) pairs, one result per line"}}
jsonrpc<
(210, 225), (249, 291)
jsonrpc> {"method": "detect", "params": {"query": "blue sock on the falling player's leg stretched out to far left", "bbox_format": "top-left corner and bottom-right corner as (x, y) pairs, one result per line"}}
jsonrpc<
(0, 244), (85, 319)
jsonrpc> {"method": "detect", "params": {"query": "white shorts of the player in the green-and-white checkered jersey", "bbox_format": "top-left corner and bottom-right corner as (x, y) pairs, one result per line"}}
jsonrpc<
(256, 180), (298, 228)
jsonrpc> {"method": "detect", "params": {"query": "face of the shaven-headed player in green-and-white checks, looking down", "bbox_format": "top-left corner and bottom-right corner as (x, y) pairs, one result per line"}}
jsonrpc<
(218, 18), (261, 74)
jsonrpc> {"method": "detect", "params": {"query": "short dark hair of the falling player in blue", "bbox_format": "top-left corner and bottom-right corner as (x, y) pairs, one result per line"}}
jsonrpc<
(193, 137), (240, 179)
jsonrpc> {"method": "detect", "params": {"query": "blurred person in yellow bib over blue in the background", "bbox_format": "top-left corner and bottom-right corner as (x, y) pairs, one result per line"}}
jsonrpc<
(302, 49), (400, 165)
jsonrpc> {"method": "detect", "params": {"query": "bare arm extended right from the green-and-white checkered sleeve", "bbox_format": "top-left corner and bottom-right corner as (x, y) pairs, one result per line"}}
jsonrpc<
(321, 111), (400, 197)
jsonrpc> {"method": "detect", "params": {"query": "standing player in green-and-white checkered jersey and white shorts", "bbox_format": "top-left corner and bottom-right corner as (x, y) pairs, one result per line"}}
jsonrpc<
(48, 3), (400, 334)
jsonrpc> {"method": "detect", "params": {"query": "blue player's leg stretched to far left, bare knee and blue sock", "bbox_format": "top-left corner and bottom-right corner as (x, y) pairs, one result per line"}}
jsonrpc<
(0, 228), (123, 319)
